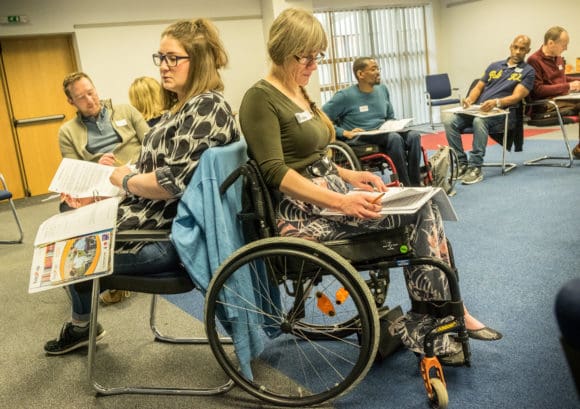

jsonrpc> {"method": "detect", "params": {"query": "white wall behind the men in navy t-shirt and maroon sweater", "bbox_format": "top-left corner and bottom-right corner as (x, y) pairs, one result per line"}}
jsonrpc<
(434, 0), (580, 95)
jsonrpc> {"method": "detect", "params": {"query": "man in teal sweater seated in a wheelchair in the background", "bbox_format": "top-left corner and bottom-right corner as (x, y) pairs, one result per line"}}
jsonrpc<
(322, 57), (421, 186)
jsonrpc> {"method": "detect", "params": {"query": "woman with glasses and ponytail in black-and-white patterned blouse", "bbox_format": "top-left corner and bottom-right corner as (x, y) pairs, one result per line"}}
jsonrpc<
(44, 19), (239, 355)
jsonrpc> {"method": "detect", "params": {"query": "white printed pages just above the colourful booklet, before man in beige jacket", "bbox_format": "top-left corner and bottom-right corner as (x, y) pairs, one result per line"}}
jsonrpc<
(48, 158), (122, 197)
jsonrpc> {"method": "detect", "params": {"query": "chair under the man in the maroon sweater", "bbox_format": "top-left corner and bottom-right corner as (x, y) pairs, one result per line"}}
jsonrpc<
(524, 99), (580, 168)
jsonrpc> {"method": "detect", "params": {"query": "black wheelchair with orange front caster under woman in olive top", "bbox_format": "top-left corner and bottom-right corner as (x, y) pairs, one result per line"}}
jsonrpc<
(204, 160), (470, 408)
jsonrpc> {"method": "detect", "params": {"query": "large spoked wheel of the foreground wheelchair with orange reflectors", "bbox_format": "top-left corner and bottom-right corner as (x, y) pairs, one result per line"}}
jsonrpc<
(205, 237), (379, 407)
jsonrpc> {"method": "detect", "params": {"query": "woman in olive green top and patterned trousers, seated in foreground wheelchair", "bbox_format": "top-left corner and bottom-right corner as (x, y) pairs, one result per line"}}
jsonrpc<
(240, 9), (501, 356)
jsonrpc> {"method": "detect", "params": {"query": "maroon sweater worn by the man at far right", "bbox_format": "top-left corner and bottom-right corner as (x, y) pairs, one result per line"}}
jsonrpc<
(528, 47), (574, 100)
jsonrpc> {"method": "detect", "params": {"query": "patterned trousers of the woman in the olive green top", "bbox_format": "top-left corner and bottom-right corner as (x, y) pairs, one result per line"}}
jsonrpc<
(277, 175), (461, 355)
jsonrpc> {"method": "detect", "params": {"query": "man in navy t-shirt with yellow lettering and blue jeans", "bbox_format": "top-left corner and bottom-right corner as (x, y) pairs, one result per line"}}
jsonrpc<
(443, 35), (535, 185)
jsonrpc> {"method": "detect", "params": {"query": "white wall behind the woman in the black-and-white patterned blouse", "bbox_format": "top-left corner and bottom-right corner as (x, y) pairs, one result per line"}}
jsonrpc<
(0, 0), (267, 110)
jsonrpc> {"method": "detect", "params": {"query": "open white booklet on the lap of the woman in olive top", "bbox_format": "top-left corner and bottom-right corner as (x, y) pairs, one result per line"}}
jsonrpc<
(320, 187), (458, 221)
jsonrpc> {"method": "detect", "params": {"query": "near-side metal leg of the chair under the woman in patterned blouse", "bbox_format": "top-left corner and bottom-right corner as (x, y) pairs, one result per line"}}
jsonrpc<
(88, 279), (234, 396)
